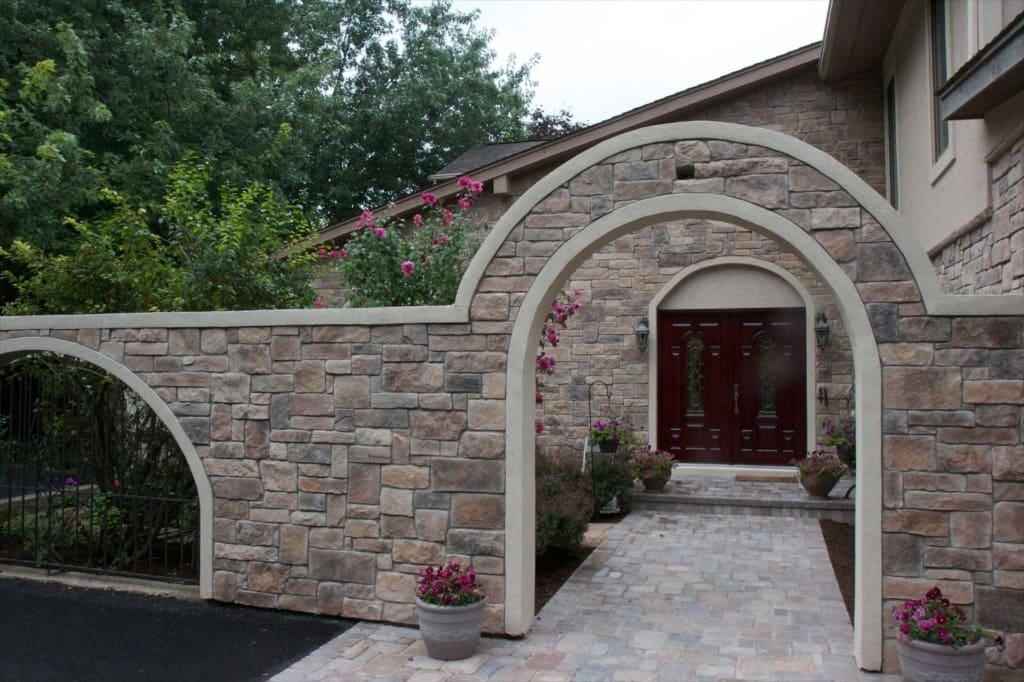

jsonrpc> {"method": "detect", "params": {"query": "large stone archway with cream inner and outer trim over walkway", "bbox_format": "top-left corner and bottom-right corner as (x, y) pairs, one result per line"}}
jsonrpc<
(473, 122), (1014, 670)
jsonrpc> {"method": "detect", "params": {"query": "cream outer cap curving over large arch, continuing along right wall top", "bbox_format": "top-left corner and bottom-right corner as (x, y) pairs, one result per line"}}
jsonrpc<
(456, 121), (1022, 315)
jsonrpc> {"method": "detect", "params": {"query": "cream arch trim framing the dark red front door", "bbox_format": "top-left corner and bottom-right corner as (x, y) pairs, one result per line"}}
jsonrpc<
(647, 251), (818, 450)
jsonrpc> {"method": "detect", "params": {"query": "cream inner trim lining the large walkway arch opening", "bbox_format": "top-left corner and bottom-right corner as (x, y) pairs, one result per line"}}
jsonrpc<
(505, 194), (882, 670)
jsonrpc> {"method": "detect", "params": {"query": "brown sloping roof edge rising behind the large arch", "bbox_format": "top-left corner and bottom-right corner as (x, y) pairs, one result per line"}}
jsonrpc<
(319, 43), (821, 242)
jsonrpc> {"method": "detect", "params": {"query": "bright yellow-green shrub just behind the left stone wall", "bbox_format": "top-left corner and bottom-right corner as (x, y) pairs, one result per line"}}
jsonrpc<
(0, 159), (316, 314)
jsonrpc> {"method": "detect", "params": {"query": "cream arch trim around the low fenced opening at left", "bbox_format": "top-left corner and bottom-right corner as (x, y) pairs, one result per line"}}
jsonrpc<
(0, 337), (213, 599)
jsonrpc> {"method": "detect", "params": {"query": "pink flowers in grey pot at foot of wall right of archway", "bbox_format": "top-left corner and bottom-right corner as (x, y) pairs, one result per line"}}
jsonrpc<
(893, 587), (1002, 682)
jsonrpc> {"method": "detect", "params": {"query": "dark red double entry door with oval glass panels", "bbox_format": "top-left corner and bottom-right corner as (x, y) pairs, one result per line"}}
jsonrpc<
(657, 308), (807, 464)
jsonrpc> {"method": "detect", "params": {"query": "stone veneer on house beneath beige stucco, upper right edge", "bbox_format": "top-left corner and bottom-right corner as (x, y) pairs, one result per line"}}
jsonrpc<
(934, 137), (1024, 294)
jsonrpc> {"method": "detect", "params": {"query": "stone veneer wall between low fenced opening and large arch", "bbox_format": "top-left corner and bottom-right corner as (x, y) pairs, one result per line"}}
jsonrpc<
(2, 323), (506, 631)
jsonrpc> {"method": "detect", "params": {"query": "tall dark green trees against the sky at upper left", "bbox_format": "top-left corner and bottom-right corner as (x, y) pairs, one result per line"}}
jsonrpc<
(0, 0), (530, 274)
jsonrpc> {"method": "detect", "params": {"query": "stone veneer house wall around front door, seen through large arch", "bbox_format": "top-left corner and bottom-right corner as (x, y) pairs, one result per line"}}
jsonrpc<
(538, 219), (853, 453)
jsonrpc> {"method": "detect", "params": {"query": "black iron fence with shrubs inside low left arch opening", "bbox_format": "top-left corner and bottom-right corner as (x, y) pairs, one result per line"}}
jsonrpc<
(0, 353), (199, 583)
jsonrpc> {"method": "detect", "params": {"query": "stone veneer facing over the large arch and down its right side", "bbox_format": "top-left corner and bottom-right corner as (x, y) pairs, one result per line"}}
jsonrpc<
(475, 135), (1024, 680)
